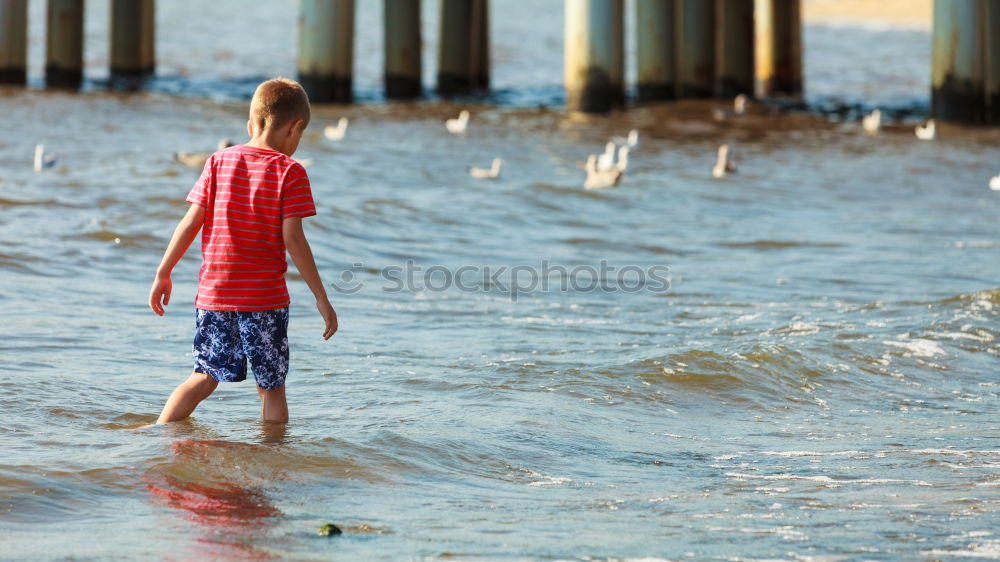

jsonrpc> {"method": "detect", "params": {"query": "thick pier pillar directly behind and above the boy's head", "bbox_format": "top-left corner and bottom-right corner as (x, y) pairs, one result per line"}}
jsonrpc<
(298, 0), (354, 103)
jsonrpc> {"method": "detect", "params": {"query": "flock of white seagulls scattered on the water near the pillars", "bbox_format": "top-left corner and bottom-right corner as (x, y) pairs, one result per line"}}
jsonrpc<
(25, 95), (1000, 191)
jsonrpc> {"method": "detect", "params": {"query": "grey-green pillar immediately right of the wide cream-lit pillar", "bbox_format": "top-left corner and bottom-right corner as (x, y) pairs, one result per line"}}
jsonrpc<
(635, 0), (680, 101)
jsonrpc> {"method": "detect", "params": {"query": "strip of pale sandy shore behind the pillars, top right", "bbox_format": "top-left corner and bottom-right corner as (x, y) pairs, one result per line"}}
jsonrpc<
(802, 0), (934, 29)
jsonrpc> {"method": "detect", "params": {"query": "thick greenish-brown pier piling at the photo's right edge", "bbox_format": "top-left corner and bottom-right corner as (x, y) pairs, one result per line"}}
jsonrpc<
(931, 0), (1000, 125)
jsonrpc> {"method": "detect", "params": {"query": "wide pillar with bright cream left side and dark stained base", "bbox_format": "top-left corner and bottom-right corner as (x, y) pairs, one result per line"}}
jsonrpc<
(564, 0), (625, 113)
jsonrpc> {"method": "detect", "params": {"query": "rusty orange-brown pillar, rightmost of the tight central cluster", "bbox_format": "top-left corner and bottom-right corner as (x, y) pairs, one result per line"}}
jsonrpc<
(754, 0), (802, 97)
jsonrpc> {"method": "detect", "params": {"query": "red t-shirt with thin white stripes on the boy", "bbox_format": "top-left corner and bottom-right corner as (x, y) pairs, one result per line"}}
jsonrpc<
(187, 145), (316, 311)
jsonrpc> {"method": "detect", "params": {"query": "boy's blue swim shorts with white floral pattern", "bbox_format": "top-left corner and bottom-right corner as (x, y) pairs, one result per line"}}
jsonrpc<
(192, 308), (288, 390)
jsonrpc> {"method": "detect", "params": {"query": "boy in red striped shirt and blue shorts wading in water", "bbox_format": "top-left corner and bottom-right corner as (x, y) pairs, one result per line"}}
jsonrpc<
(149, 78), (337, 424)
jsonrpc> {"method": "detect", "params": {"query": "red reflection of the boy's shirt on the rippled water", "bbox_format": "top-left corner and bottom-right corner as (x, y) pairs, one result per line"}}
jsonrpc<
(143, 423), (287, 560)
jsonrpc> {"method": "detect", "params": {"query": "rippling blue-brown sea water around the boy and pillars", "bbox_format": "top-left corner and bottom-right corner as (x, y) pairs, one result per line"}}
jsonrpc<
(0, 2), (1000, 560)
